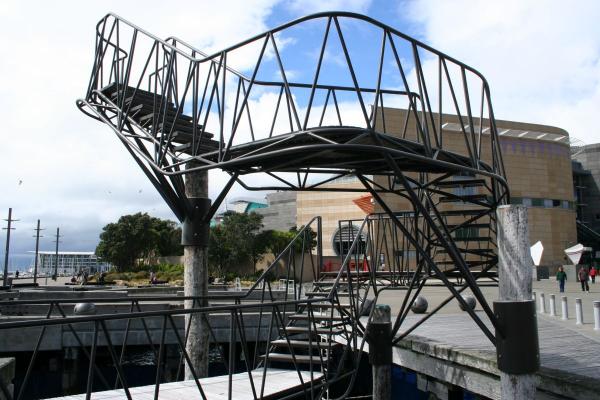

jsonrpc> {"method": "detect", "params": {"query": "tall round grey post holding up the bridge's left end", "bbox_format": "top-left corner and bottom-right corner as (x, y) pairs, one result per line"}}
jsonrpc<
(183, 170), (209, 379)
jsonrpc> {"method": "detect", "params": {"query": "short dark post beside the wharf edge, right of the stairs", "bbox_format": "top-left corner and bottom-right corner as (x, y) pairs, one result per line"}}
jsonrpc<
(367, 304), (392, 400)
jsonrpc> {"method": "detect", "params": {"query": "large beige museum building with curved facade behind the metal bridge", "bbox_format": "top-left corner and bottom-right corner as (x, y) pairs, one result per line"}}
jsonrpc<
(297, 109), (576, 266)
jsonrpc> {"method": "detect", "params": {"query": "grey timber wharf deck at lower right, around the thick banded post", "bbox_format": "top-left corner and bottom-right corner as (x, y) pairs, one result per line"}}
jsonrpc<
(358, 312), (600, 400)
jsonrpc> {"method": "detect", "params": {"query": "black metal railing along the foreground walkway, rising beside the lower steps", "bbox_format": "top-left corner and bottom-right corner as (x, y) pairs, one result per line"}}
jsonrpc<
(0, 217), (378, 400)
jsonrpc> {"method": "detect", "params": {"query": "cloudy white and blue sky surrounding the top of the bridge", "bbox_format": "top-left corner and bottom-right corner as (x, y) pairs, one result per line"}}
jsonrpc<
(0, 0), (600, 267)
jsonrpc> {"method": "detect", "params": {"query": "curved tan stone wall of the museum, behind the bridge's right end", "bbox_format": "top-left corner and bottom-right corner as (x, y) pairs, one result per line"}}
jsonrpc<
(376, 109), (577, 265)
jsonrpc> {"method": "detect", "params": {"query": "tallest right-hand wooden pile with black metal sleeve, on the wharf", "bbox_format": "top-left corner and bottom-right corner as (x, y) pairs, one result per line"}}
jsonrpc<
(494, 205), (541, 400)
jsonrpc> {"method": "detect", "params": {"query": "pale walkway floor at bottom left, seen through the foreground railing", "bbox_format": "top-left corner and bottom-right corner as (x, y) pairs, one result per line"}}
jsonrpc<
(55, 368), (322, 400)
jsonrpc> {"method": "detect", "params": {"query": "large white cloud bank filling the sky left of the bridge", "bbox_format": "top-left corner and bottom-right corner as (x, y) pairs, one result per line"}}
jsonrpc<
(0, 0), (277, 262)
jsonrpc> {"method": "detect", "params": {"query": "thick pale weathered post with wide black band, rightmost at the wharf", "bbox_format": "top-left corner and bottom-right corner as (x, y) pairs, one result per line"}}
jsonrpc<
(497, 205), (539, 400)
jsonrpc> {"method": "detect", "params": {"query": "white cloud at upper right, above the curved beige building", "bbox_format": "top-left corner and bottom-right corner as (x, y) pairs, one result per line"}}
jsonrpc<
(406, 0), (600, 143)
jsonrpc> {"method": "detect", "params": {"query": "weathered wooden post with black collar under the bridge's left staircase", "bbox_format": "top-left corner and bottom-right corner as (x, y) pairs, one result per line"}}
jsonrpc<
(181, 165), (210, 379)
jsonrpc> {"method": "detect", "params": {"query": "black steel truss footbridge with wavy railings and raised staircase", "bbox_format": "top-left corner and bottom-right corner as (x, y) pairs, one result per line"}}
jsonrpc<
(64, 12), (509, 397)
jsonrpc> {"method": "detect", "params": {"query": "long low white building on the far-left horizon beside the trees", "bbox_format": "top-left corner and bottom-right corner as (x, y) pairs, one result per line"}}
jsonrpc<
(32, 251), (111, 275)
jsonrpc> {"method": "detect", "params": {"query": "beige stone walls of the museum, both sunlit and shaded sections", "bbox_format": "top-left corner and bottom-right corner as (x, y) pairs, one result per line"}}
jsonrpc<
(297, 109), (577, 265)
